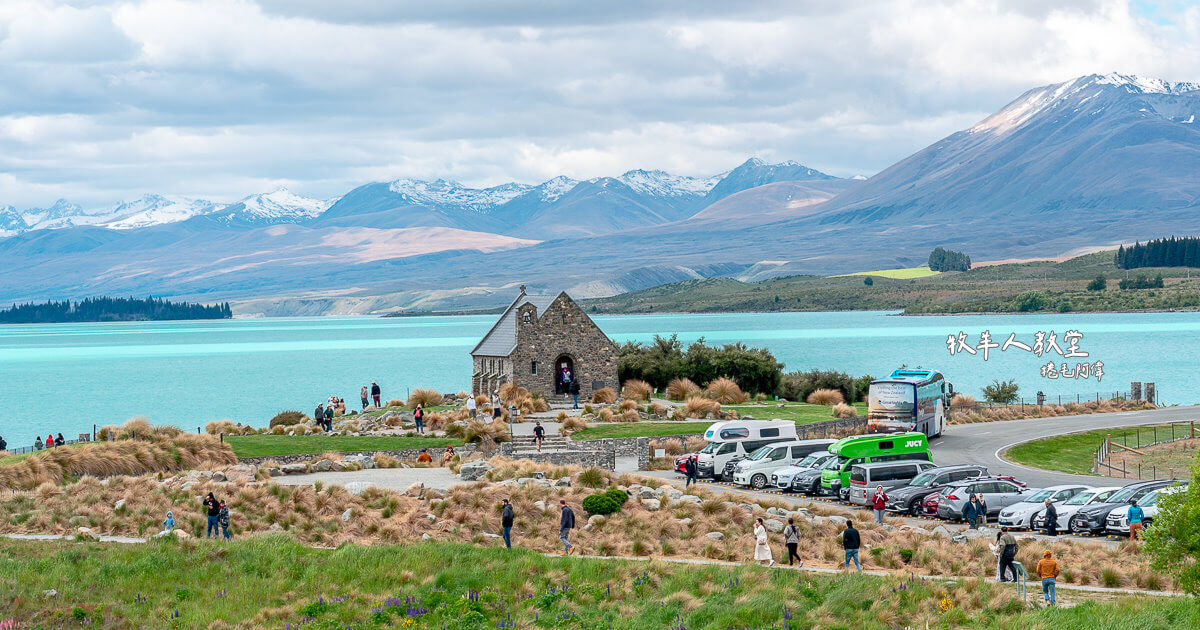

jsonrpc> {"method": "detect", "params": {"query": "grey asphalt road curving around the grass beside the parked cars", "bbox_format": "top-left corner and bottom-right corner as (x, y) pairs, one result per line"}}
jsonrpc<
(930, 407), (1200, 487)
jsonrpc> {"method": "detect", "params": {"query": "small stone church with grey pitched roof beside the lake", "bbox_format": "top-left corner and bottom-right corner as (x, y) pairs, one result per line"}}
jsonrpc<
(470, 286), (618, 398)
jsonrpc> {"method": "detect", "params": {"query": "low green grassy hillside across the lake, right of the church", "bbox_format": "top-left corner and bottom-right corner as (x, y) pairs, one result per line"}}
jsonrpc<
(583, 252), (1200, 313)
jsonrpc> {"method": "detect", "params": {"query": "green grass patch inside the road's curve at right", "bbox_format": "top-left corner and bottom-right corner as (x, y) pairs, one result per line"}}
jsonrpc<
(1004, 425), (1187, 475)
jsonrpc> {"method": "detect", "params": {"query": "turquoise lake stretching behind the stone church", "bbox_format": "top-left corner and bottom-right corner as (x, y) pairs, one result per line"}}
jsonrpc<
(0, 312), (1200, 448)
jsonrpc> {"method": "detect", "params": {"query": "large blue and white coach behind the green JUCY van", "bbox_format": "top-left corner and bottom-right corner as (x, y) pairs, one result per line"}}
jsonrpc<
(866, 368), (954, 438)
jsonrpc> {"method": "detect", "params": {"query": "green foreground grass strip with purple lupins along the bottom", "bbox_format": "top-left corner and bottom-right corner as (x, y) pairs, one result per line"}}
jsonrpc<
(0, 535), (1200, 630)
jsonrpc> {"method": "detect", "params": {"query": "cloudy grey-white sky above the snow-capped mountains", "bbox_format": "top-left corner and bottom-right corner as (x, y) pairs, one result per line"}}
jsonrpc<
(0, 0), (1200, 208)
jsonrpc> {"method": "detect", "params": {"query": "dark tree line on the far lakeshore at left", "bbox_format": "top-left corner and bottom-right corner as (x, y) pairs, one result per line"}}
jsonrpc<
(0, 296), (233, 324)
